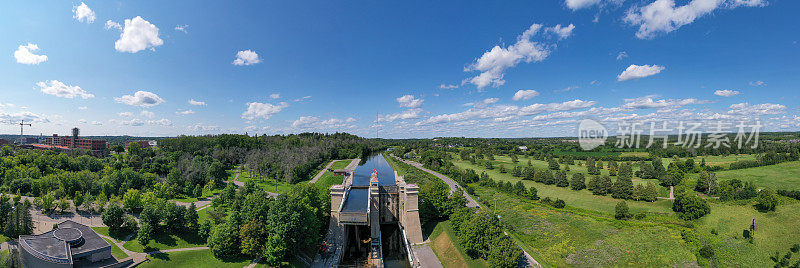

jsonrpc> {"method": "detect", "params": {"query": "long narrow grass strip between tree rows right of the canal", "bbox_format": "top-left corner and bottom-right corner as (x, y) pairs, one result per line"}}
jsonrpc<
(454, 157), (673, 215)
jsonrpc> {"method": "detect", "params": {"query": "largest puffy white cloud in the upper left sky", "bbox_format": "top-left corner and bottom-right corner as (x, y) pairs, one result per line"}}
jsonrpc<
(114, 16), (164, 53)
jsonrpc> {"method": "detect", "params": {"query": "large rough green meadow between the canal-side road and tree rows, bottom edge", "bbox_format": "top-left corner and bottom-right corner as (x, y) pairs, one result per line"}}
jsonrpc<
(475, 185), (696, 267)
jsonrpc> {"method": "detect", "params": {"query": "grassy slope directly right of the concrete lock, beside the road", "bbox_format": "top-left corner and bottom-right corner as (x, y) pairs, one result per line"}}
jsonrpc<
(425, 220), (489, 267)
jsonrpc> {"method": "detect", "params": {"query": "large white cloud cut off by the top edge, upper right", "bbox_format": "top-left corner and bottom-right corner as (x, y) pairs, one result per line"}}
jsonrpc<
(623, 0), (766, 39)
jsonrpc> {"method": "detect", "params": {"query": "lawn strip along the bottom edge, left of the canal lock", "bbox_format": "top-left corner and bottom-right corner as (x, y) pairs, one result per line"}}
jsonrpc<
(139, 249), (261, 268)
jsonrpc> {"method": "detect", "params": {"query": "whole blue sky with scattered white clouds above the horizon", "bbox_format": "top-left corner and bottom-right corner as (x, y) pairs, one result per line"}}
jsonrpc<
(0, 0), (800, 138)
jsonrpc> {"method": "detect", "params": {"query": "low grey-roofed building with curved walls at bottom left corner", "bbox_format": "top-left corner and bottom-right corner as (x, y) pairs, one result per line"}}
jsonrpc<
(18, 220), (112, 268)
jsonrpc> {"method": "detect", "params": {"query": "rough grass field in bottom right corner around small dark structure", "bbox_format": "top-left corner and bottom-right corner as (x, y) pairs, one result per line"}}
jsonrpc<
(696, 199), (800, 267)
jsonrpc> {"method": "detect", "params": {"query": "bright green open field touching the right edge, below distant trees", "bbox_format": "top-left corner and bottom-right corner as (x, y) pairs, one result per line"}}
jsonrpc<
(716, 161), (800, 190)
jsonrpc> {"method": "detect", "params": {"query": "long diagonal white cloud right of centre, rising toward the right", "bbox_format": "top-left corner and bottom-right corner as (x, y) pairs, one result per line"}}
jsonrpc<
(464, 24), (575, 89)
